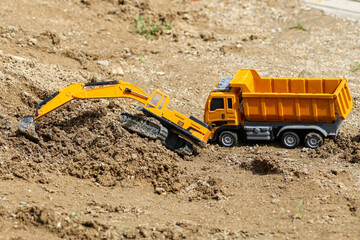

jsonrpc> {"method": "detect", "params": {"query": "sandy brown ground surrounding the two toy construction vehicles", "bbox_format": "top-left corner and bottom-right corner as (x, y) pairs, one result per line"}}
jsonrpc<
(0, 0), (360, 240)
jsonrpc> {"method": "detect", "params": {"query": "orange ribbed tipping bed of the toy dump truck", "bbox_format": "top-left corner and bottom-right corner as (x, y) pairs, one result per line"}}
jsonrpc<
(229, 70), (353, 122)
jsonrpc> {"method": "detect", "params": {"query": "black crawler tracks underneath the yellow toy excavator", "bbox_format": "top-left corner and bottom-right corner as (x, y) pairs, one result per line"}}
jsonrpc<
(120, 112), (193, 155)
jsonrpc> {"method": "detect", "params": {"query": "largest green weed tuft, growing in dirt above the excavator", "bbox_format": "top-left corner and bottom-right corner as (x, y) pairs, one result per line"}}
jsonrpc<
(135, 15), (171, 39)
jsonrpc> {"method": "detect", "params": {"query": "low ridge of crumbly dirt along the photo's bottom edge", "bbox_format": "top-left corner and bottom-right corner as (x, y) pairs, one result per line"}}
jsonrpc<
(16, 206), (241, 240)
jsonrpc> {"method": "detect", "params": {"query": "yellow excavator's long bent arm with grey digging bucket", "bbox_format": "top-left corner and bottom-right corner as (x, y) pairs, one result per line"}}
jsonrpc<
(18, 81), (149, 141)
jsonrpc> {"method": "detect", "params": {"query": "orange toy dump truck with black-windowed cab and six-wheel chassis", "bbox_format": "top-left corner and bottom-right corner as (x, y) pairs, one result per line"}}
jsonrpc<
(204, 69), (353, 148)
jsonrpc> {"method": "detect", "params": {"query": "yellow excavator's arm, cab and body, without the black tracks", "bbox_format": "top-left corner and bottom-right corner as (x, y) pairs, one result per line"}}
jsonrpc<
(19, 81), (211, 152)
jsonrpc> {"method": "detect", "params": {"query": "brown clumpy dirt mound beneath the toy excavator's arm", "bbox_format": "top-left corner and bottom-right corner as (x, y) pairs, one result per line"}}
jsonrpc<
(1, 104), (186, 192)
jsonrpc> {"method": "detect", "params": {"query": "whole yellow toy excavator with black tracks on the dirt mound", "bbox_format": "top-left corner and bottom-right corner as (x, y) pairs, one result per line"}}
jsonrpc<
(18, 81), (211, 155)
